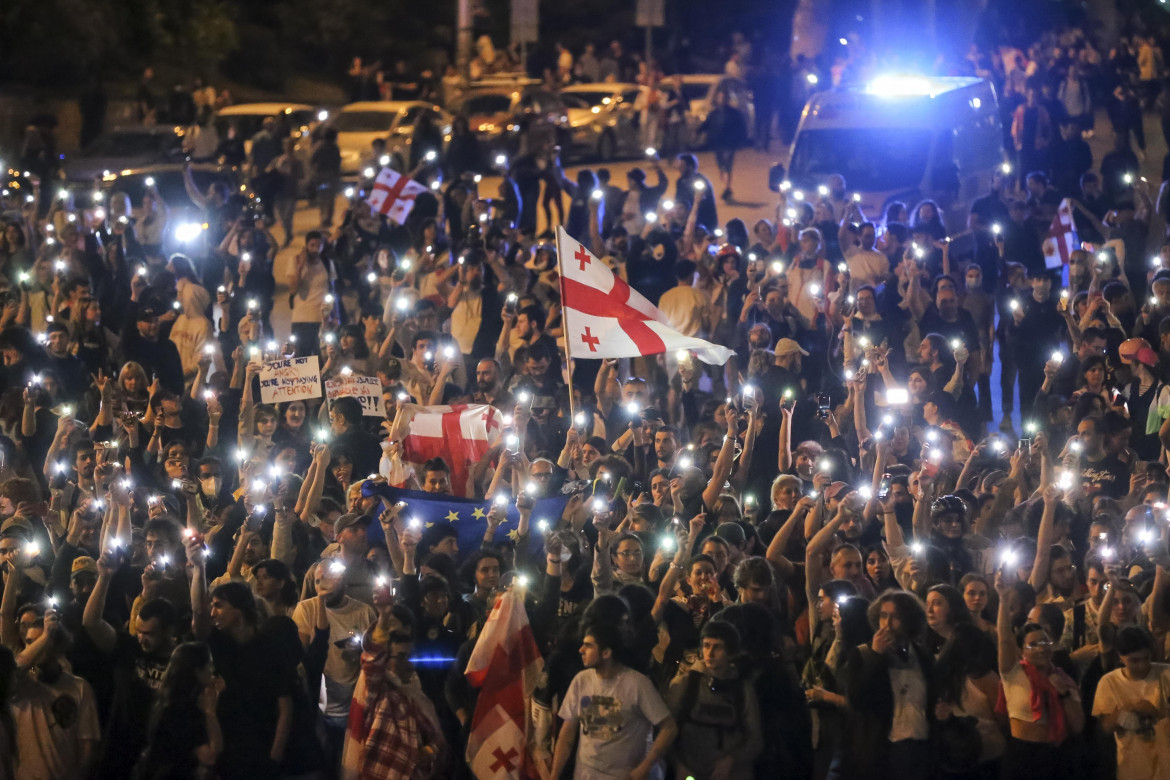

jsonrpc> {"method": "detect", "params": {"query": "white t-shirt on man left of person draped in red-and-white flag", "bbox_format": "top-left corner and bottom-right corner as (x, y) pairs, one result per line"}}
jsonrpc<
(293, 596), (378, 717)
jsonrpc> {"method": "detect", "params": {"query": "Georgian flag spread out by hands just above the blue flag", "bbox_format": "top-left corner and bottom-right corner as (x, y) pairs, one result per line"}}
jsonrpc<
(391, 403), (502, 496)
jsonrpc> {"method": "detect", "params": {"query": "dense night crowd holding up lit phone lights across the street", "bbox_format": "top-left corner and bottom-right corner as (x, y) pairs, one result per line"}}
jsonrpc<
(0, 16), (1170, 780)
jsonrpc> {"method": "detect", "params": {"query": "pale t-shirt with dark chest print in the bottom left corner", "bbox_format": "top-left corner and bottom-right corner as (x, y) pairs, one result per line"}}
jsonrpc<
(9, 672), (102, 780)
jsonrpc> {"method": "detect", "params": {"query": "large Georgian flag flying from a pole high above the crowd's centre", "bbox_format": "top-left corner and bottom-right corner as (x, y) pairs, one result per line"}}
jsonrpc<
(557, 227), (735, 365)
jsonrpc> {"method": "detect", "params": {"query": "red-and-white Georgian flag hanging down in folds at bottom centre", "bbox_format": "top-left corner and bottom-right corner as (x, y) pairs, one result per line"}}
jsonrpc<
(464, 586), (544, 780)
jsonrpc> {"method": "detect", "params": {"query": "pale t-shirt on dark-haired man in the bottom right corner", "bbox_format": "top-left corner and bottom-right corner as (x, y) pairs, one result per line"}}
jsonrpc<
(1093, 663), (1170, 780)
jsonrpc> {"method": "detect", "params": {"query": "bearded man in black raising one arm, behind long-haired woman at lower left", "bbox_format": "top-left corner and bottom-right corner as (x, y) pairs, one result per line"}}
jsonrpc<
(78, 552), (179, 780)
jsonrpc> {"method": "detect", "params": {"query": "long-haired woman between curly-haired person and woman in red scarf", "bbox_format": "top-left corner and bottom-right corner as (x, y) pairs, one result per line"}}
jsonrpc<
(928, 622), (1005, 780)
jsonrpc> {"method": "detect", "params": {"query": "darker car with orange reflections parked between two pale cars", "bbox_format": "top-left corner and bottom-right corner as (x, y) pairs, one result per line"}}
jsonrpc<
(452, 84), (570, 159)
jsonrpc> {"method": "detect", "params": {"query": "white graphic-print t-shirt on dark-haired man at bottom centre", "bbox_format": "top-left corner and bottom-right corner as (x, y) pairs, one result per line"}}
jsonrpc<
(559, 667), (670, 780)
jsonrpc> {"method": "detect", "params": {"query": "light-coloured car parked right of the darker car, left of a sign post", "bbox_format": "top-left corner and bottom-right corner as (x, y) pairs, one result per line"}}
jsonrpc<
(560, 83), (642, 160)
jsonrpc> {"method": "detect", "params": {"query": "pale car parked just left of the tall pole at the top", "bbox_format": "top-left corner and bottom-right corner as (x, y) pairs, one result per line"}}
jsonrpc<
(333, 101), (450, 178)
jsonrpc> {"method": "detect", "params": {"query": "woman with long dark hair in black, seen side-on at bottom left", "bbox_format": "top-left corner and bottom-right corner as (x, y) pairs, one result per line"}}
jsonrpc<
(135, 642), (223, 780)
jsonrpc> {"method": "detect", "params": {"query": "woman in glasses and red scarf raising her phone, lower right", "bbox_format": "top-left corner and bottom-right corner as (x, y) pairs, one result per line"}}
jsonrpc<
(996, 519), (1085, 780)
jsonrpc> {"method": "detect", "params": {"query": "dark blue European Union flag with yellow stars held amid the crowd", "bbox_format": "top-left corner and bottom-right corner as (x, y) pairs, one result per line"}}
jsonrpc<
(363, 483), (569, 560)
